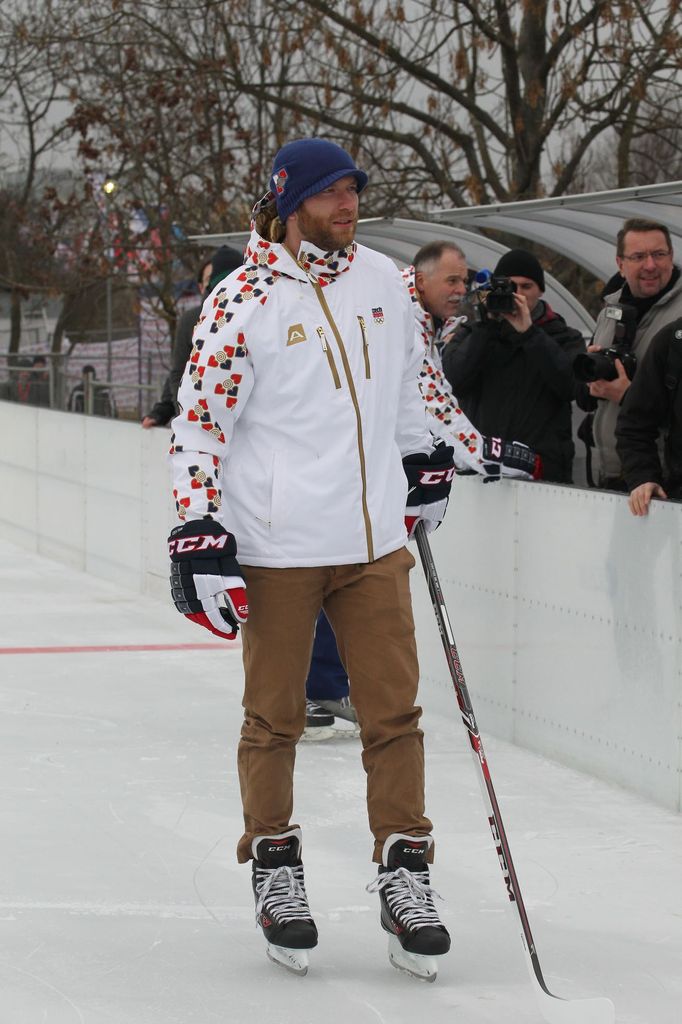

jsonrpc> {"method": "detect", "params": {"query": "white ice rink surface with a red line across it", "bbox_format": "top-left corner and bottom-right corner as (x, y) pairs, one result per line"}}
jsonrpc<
(0, 544), (682, 1024)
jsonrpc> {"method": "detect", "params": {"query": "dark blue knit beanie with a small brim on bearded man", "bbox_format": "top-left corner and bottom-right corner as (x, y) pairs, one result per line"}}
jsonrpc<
(270, 138), (368, 223)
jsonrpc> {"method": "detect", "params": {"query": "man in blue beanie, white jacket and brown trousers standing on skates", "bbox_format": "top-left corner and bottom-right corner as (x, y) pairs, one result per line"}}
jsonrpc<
(169, 138), (454, 977)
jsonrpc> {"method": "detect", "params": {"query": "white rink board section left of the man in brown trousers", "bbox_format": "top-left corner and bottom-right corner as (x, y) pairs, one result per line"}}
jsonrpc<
(0, 402), (175, 598)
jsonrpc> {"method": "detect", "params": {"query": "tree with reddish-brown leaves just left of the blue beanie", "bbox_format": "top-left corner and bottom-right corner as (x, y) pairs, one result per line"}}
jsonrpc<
(45, 0), (296, 333)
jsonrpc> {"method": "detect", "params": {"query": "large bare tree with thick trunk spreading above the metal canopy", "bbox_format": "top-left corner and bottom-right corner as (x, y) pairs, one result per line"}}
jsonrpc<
(110, 0), (682, 212)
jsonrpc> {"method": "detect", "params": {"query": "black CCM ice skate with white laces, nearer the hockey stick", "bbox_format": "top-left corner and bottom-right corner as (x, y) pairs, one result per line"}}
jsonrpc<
(367, 833), (450, 981)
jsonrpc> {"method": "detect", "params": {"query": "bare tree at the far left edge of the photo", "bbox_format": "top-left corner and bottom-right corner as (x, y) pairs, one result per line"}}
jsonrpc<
(0, 0), (105, 352)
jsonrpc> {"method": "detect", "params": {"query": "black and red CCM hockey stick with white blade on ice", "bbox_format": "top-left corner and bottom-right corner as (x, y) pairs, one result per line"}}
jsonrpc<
(415, 522), (615, 1024)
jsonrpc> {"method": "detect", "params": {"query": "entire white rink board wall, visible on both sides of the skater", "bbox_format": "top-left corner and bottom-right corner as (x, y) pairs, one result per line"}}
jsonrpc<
(0, 402), (682, 811)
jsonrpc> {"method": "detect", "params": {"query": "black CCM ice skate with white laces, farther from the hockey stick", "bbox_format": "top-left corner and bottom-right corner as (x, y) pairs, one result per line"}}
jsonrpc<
(251, 828), (317, 974)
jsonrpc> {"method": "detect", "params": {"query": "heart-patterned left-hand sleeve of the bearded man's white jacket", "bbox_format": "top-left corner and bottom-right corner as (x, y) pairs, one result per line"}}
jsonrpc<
(170, 290), (254, 528)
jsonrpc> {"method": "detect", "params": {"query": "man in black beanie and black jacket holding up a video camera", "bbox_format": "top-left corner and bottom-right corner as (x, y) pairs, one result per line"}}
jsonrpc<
(442, 249), (585, 483)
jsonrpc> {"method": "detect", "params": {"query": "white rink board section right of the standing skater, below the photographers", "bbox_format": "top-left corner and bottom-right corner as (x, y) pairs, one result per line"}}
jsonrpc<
(414, 478), (682, 811)
